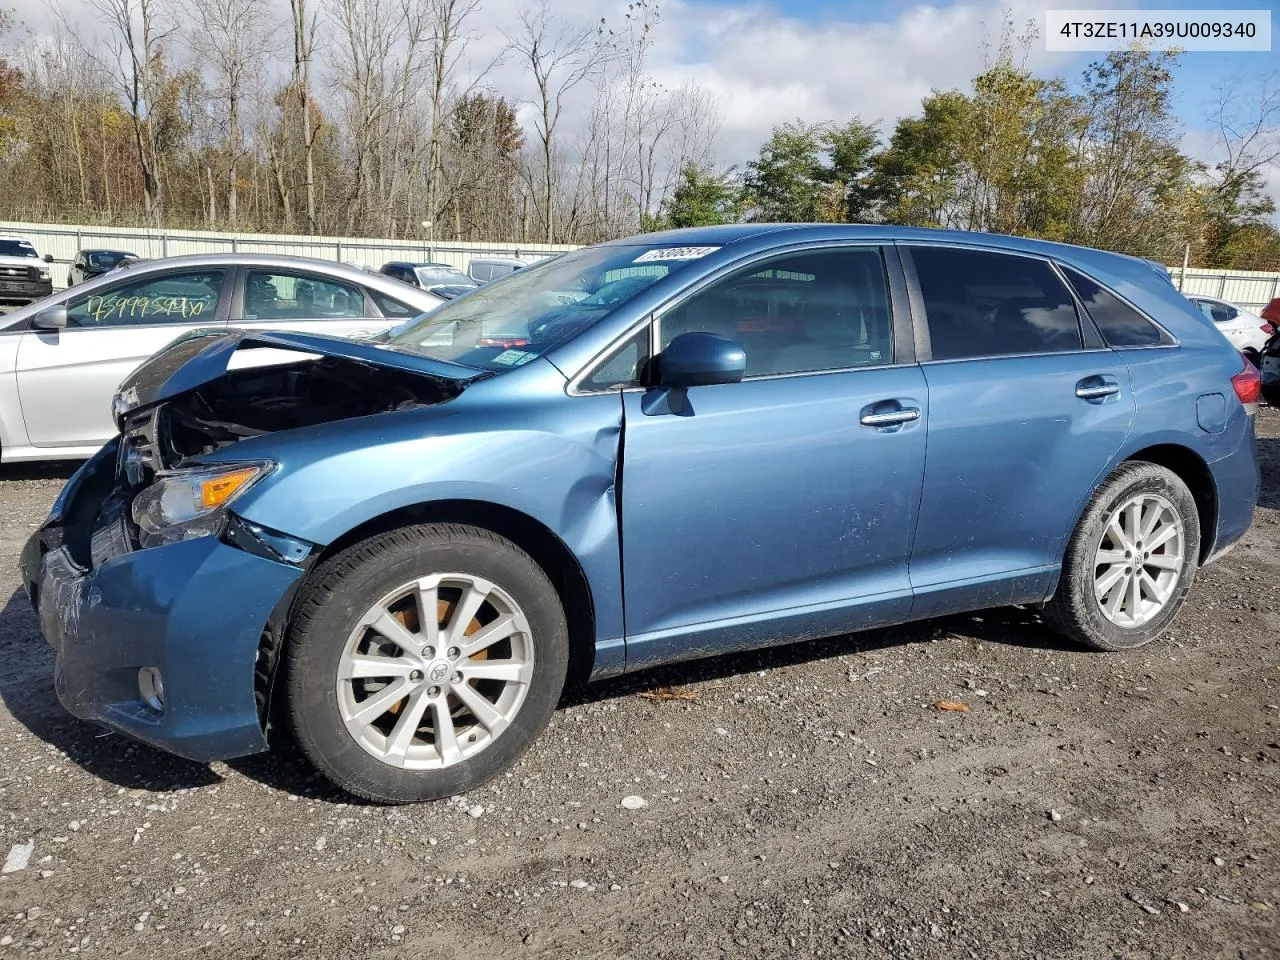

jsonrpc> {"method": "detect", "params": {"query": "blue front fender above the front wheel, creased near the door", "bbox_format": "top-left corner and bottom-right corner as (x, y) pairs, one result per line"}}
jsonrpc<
(227, 393), (623, 660)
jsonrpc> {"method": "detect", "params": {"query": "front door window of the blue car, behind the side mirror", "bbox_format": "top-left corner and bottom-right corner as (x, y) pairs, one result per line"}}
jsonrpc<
(662, 247), (893, 376)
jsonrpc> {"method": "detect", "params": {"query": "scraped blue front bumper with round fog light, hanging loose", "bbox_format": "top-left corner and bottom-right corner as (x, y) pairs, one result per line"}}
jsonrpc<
(22, 506), (302, 763)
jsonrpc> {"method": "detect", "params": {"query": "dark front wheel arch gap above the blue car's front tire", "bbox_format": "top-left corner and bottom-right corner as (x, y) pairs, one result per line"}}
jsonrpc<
(256, 499), (595, 721)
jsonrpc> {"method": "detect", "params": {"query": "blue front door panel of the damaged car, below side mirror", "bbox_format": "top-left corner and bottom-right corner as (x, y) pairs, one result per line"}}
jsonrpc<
(622, 366), (928, 668)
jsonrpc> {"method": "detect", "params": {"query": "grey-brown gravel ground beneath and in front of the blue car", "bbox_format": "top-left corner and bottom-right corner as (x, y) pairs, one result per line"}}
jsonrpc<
(0, 410), (1280, 960)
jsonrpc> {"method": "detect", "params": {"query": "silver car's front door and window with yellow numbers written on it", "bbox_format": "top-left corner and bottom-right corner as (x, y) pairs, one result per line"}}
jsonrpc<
(18, 270), (225, 447)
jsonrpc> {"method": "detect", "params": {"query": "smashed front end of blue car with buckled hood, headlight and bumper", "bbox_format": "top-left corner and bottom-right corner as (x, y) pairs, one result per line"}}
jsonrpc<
(22, 332), (477, 760)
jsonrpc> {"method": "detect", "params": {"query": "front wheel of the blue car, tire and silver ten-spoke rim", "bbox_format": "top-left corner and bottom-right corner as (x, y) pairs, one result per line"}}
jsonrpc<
(293, 524), (568, 804)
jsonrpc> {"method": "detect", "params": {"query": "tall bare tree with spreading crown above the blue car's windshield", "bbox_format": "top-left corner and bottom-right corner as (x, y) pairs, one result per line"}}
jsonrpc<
(507, 0), (604, 243)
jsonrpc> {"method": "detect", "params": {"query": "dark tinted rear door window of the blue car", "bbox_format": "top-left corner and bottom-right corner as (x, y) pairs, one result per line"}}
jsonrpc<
(911, 247), (1083, 360)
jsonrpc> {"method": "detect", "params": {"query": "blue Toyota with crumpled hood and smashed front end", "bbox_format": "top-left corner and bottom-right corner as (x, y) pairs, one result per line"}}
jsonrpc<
(23, 224), (1258, 801)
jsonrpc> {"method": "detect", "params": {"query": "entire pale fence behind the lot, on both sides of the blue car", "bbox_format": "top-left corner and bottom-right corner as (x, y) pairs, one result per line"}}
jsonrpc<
(10, 220), (1280, 305)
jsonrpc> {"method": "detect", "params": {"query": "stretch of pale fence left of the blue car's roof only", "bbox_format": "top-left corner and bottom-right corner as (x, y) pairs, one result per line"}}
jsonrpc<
(0, 220), (573, 288)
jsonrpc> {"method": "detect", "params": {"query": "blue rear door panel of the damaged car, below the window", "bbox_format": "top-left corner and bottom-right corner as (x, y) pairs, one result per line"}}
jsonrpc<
(911, 351), (1134, 616)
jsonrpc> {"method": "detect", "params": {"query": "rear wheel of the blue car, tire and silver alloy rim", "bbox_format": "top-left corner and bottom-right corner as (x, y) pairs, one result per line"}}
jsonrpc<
(1044, 461), (1201, 652)
